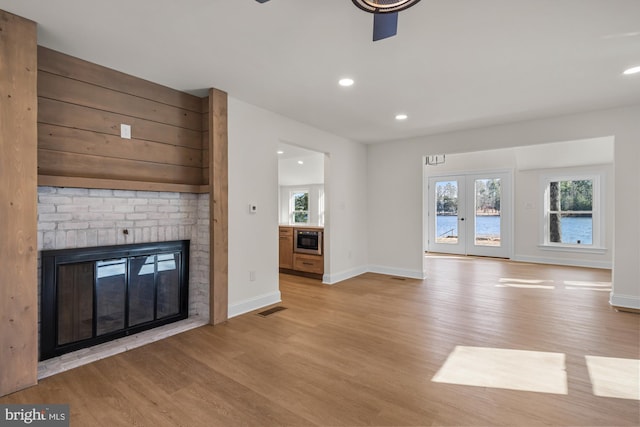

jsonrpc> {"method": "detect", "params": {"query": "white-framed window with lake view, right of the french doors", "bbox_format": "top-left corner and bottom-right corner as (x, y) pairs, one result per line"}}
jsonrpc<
(543, 175), (601, 249)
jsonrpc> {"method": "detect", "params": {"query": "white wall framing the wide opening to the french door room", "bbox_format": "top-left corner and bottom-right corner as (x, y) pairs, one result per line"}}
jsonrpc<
(368, 105), (640, 308)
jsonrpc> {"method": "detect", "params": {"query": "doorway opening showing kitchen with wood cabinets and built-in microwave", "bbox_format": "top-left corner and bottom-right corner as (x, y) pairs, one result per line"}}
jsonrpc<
(278, 143), (327, 281)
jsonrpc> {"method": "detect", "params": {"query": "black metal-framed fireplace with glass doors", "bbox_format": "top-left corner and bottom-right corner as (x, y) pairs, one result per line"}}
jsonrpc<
(40, 240), (189, 360)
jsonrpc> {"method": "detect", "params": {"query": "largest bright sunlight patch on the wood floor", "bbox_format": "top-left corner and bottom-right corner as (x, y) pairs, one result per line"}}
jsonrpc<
(432, 346), (567, 394)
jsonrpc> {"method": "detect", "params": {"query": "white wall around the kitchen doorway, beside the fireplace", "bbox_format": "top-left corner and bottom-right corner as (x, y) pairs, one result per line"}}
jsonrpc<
(228, 96), (367, 317)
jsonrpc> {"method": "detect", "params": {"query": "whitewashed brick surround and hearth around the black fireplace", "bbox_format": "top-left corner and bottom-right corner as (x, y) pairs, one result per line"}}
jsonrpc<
(38, 187), (209, 379)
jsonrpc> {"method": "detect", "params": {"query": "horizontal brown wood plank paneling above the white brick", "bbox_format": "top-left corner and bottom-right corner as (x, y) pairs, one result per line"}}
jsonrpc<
(38, 46), (209, 192)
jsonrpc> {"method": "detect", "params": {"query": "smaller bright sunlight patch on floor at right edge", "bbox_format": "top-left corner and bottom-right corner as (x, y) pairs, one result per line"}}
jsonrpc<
(585, 356), (640, 400)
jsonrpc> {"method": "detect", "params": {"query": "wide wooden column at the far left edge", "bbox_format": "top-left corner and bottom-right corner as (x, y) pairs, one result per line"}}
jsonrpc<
(0, 10), (38, 396)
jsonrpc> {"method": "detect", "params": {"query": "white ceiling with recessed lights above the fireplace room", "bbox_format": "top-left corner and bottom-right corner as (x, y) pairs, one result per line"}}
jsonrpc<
(0, 0), (640, 143)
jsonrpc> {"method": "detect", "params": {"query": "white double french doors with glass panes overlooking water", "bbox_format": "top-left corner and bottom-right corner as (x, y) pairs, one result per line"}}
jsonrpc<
(427, 172), (512, 258)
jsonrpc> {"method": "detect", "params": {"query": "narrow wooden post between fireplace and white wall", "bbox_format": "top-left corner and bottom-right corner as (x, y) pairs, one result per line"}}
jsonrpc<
(208, 89), (229, 325)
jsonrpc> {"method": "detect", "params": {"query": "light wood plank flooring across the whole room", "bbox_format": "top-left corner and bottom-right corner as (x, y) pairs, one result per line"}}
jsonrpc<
(0, 256), (640, 427)
